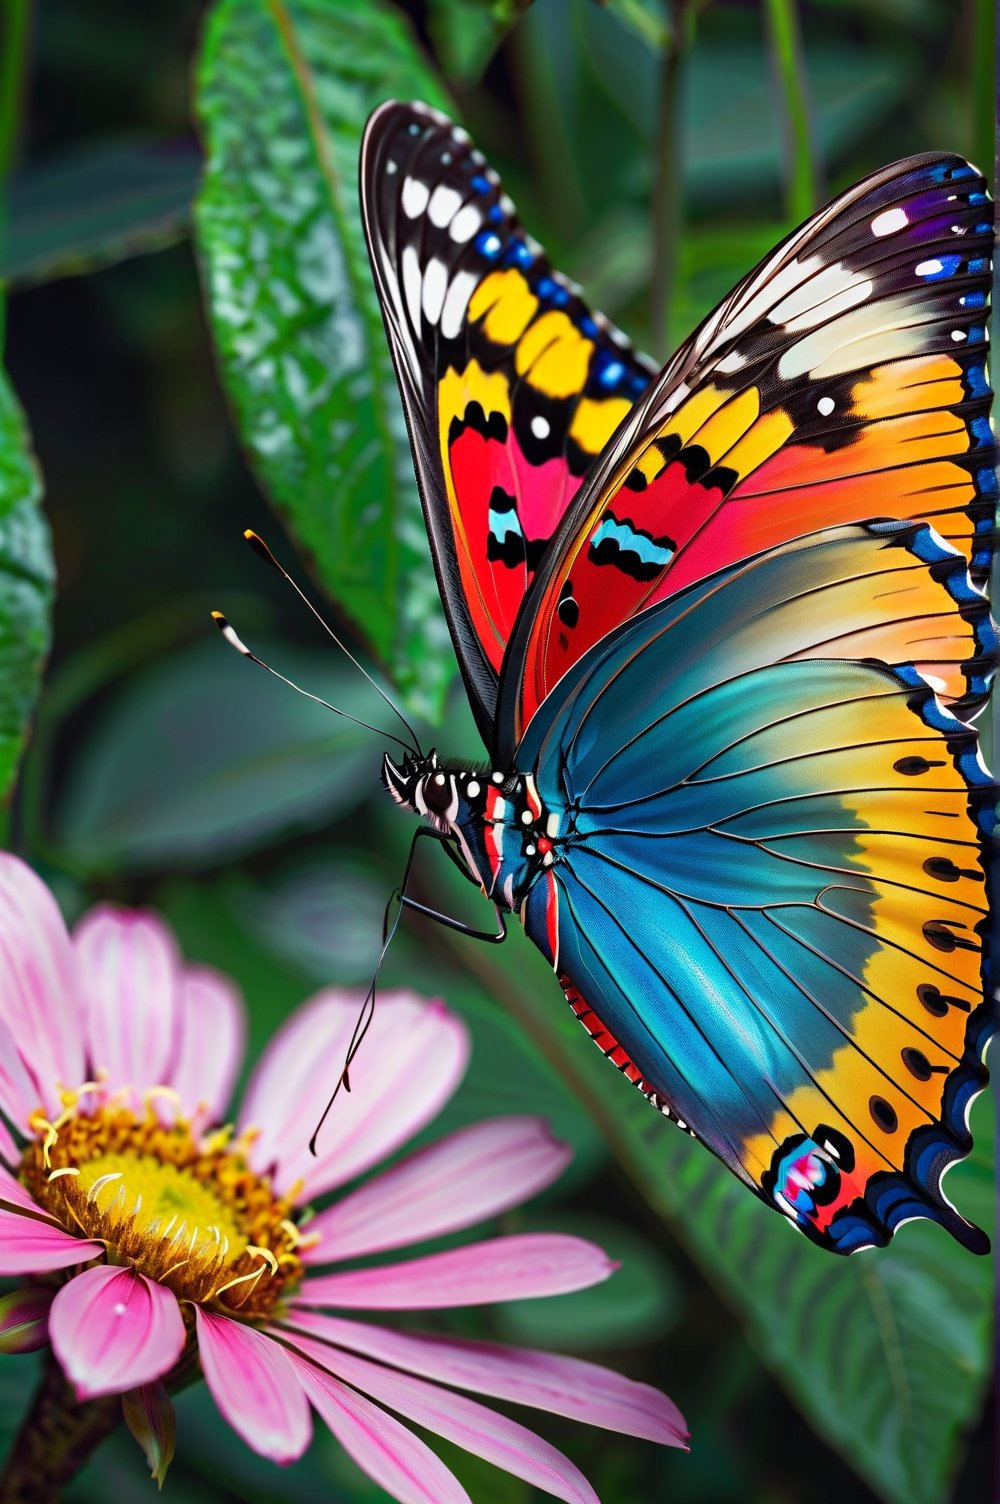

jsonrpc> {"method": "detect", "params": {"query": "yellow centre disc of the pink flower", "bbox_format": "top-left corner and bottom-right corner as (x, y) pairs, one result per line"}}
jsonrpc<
(20, 1089), (302, 1319)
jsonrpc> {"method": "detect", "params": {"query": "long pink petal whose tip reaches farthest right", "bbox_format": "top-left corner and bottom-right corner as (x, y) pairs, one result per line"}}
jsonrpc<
(281, 1310), (687, 1447)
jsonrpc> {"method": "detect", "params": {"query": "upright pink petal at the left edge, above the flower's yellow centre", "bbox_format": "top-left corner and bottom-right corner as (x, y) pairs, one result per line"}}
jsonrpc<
(0, 853), (84, 1125)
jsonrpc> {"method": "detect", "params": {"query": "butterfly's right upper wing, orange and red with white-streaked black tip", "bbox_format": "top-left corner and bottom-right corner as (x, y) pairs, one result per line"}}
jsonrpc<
(495, 155), (997, 760)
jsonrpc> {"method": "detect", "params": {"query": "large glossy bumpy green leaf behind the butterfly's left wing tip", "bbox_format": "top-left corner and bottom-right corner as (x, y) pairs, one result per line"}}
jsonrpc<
(195, 0), (456, 717)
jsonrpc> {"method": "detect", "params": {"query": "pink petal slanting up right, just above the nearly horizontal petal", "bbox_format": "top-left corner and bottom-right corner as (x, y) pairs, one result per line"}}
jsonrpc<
(305, 1117), (573, 1263)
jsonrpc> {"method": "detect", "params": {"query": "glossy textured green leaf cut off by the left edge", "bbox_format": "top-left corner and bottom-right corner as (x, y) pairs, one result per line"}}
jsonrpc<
(0, 370), (54, 803)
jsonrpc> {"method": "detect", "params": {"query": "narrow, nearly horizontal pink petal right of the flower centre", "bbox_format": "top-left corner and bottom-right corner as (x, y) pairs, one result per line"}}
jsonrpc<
(295, 1232), (618, 1311)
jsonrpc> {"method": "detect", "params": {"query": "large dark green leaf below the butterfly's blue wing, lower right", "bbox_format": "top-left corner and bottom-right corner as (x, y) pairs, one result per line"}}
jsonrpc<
(424, 862), (994, 1504)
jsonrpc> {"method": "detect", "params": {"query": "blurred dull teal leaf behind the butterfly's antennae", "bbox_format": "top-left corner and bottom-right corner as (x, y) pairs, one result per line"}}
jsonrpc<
(54, 627), (377, 874)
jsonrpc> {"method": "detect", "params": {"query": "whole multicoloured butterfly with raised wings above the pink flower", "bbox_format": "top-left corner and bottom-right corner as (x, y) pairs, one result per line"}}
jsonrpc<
(361, 102), (998, 1254)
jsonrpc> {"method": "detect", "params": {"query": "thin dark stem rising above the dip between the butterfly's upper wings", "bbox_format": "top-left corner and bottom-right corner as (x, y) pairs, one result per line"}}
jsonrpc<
(650, 0), (693, 359)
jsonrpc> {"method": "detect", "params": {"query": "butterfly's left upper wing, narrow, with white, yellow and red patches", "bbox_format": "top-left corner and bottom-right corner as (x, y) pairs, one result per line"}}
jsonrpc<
(361, 104), (653, 743)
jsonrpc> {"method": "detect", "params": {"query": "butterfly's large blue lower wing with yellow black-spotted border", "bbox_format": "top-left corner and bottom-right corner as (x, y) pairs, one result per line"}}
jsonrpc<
(516, 522), (997, 1253)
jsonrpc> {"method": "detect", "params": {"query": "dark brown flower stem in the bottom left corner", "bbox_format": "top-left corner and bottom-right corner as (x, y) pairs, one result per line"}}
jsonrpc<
(0, 1357), (122, 1504)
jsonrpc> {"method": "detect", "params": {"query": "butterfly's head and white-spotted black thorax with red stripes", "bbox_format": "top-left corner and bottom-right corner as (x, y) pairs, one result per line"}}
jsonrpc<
(382, 750), (568, 910)
